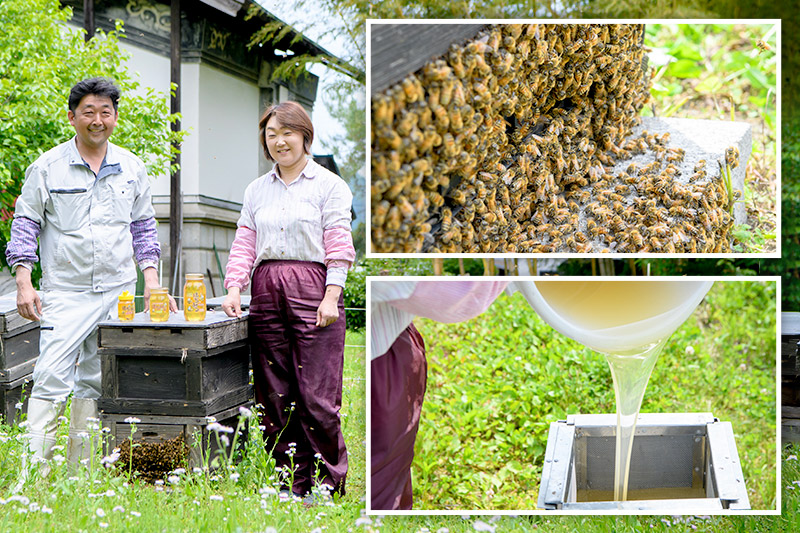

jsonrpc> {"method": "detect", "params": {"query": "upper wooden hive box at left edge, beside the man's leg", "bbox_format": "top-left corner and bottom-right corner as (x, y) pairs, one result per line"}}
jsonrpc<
(0, 292), (39, 383)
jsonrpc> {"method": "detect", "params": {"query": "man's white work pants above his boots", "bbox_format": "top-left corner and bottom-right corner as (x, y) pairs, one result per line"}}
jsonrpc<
(31, 284), (135, 401)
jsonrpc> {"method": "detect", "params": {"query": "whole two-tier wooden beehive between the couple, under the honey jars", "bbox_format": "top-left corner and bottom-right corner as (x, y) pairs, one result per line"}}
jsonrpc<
(98, 313), (252, 466)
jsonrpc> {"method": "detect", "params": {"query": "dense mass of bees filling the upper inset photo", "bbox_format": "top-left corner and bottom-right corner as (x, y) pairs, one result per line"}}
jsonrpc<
(371, 24), (738, 253)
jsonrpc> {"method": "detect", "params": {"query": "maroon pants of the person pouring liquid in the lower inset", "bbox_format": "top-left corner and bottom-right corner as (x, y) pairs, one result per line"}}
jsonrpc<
(370, 324), (428, 510)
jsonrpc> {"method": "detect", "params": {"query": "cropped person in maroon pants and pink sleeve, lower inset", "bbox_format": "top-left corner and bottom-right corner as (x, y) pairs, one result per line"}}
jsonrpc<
(369, 279), (507, 511)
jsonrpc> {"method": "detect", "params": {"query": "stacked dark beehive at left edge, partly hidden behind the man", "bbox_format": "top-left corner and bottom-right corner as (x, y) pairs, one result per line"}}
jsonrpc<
(0, 292), (39, 424)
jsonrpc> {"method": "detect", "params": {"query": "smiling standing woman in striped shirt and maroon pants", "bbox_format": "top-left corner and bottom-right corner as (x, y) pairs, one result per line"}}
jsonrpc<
(222, 102), (355, 496)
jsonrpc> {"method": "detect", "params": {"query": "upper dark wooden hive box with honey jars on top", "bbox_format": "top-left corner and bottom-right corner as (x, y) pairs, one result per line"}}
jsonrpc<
(98, 312), (252, 417)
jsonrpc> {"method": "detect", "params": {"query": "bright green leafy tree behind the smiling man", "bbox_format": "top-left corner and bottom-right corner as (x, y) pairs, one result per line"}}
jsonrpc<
(0, 0), (183, 272)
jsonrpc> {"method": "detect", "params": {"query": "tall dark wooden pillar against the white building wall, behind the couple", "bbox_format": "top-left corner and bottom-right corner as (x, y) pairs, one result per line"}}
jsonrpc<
(169, 0), (183, 294)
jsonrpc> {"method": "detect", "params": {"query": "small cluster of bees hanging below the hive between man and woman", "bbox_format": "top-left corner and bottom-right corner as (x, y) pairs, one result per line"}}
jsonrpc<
(115, 434), (189, 483)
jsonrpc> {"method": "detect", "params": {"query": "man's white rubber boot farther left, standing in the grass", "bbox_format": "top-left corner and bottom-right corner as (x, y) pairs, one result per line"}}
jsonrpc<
(13, 398), (64, 492)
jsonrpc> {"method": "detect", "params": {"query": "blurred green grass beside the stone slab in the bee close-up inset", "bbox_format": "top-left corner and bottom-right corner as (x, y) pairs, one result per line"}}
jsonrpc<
(644, 24), (780, 253)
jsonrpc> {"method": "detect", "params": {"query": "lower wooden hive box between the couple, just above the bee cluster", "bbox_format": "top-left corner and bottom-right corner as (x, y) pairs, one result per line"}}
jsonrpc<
(100, 402), (253, 468)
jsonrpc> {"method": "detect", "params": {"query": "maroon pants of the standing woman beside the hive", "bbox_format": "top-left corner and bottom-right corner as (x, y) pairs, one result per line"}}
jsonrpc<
(250, 261), (347, 494)
